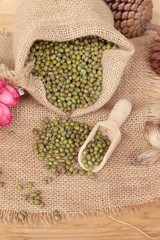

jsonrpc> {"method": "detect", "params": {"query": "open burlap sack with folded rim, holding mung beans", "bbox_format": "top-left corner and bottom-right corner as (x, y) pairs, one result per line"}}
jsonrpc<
(13, 0), (134, 116)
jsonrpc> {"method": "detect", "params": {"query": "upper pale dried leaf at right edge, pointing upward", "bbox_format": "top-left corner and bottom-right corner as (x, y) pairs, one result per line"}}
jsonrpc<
(144, 122), (160, 150)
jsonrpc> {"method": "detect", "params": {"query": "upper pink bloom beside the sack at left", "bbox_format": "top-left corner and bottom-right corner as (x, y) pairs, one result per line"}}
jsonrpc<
(0, 79), (20, 107)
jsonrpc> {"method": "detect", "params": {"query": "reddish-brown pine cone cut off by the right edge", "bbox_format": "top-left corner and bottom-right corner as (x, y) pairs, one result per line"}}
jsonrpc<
(150, 36), (160, 75)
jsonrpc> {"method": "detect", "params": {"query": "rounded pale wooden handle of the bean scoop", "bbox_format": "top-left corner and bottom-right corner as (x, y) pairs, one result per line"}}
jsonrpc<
(107, 99), (132, 128)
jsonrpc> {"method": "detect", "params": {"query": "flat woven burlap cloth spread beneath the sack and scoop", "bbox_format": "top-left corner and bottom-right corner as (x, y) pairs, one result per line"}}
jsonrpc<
(0, 30), (160, 223)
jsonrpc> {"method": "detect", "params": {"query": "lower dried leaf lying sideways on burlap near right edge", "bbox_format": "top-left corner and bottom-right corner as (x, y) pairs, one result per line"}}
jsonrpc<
(132, 149), (160, 166)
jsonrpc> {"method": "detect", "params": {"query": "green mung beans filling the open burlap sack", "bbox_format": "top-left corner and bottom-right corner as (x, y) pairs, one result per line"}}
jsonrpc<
(26, 36), (114, 114)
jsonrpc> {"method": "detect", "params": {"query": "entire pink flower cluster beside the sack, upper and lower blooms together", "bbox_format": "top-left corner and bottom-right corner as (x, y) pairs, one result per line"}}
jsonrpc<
(0, 78), (20, 127)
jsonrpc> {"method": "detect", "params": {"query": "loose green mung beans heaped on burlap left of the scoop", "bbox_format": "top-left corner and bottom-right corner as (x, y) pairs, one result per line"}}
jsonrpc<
(33, 118), (91, 176)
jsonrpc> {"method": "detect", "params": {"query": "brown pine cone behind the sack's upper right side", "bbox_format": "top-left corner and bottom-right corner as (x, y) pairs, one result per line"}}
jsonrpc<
(104, 0), (153, 38)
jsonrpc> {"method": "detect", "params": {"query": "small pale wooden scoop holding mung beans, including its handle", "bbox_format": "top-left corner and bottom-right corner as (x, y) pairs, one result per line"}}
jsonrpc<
(78, 99), (132, 172)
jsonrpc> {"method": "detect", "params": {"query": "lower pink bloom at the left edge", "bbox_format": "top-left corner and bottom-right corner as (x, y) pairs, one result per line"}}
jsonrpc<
(0, 103), (12, 127)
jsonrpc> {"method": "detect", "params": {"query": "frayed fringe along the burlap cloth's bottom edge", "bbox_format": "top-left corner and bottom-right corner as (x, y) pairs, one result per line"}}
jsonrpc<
(0, 198), (160, 227)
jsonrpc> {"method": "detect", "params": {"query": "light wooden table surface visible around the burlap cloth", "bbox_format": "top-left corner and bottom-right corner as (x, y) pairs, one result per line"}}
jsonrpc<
(0, 0), (160, 240)
